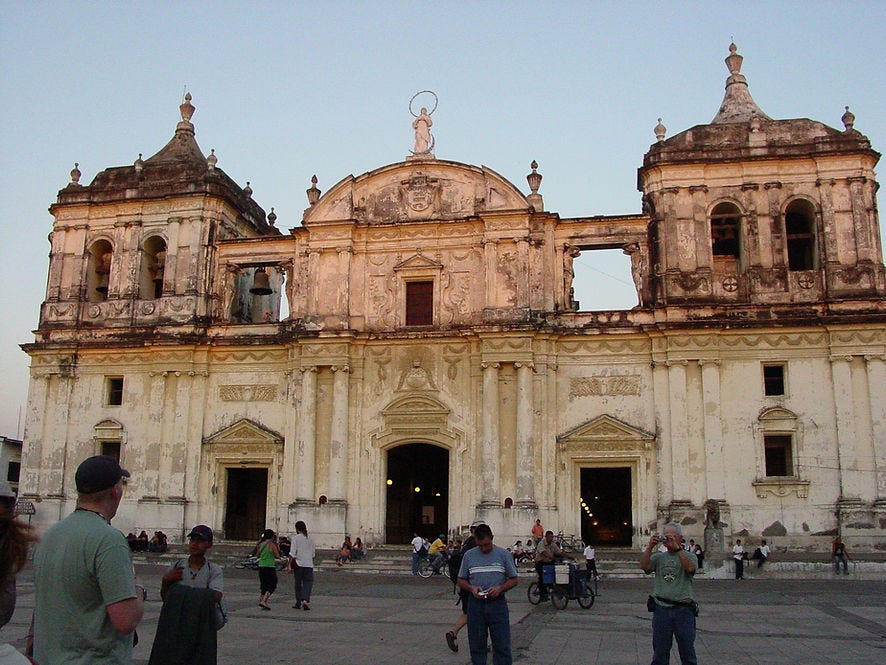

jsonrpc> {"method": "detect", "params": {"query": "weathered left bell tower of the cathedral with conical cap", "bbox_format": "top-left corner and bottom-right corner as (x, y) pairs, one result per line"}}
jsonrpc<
(38, 93), (279, 341)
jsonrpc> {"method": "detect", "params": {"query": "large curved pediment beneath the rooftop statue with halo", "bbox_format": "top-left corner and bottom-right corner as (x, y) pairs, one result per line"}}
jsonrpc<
(304, 159), (530, 226)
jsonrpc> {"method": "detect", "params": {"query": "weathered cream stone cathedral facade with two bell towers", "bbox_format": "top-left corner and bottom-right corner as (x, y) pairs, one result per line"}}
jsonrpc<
(21, 46), (886, 549)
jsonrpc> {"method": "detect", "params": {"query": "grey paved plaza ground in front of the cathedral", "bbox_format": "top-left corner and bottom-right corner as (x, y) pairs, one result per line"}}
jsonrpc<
(0, 564), (886, 665)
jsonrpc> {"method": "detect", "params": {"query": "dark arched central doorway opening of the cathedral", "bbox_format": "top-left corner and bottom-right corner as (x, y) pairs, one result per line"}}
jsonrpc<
(385, 443), (449, 544)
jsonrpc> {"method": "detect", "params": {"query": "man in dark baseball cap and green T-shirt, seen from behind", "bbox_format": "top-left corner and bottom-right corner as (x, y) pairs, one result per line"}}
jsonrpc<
(33, 455), (147, 665)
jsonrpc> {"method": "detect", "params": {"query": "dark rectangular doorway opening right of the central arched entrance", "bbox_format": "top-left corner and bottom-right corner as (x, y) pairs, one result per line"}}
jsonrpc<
(580, 467), (634, 546)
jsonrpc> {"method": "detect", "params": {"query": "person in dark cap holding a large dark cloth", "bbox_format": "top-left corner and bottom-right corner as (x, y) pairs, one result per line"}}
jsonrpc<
(148, 524), (227, 665)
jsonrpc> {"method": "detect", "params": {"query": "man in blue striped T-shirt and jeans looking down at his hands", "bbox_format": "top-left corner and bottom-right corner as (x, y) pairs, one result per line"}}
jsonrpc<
(458, 524), (517, 665)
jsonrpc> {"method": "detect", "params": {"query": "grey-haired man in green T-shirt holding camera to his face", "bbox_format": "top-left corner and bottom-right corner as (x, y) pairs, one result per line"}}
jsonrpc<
(640, 522), (698, 665)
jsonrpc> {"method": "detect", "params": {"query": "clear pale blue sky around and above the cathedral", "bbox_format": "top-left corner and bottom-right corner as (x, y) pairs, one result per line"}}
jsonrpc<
(0, 0), (886, 436)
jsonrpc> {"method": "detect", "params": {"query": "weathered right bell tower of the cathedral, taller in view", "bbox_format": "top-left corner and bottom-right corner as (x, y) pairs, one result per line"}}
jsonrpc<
(638, 44), (886, 314)
